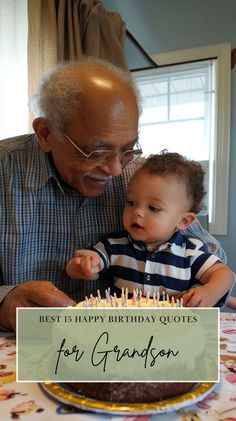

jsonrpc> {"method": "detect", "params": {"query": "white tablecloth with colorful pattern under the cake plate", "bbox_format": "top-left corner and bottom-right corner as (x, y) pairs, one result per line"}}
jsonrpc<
(0, 313), (236, 421)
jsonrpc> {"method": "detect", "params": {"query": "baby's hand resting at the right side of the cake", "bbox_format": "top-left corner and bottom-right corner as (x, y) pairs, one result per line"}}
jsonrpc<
(182, 286), (215, 307)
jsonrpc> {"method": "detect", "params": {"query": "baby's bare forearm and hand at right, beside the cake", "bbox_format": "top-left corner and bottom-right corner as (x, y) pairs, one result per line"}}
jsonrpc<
(183, 263), (234, 307)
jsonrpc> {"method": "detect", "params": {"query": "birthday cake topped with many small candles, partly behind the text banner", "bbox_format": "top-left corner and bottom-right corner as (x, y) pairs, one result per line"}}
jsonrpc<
(67, 289), (196, 403)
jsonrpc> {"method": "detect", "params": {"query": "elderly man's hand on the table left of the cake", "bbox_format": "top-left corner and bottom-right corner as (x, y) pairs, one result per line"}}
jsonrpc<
(0, 281), (75, 330)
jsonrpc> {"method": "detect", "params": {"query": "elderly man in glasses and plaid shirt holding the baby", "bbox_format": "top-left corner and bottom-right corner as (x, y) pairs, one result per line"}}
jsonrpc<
(0, 60), (227, 328)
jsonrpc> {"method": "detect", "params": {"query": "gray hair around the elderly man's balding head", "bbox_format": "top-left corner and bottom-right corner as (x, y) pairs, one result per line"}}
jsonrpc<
(30, 57), (140, 130)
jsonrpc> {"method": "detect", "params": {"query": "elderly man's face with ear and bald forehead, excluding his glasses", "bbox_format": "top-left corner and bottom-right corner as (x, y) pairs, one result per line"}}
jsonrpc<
(37, 69), (138, 196)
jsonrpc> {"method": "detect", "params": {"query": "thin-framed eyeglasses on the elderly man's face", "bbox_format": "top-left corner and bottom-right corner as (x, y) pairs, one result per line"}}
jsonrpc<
(62, 131), (143, 167)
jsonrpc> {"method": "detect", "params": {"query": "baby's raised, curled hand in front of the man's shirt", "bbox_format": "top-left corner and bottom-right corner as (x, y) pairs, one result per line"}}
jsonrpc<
(66, 250), (103, 281)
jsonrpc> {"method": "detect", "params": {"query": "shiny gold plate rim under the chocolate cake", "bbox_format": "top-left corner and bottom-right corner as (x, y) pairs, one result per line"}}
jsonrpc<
(41, 382), (216, 415)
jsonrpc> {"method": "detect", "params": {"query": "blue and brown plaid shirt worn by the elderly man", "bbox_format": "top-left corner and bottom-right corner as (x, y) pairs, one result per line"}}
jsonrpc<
(0, 134), (229, 301)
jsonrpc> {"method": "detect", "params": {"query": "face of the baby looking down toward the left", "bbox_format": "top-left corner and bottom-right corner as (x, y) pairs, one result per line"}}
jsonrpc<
(123, 170), (193, 244)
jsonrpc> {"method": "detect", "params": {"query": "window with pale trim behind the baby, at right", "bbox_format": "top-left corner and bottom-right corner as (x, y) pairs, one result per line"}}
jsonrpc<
(134, 44), (230, 234)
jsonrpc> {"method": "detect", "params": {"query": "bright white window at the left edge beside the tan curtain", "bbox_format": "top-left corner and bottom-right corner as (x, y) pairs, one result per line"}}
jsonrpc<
(0, 0), (28, 139)
